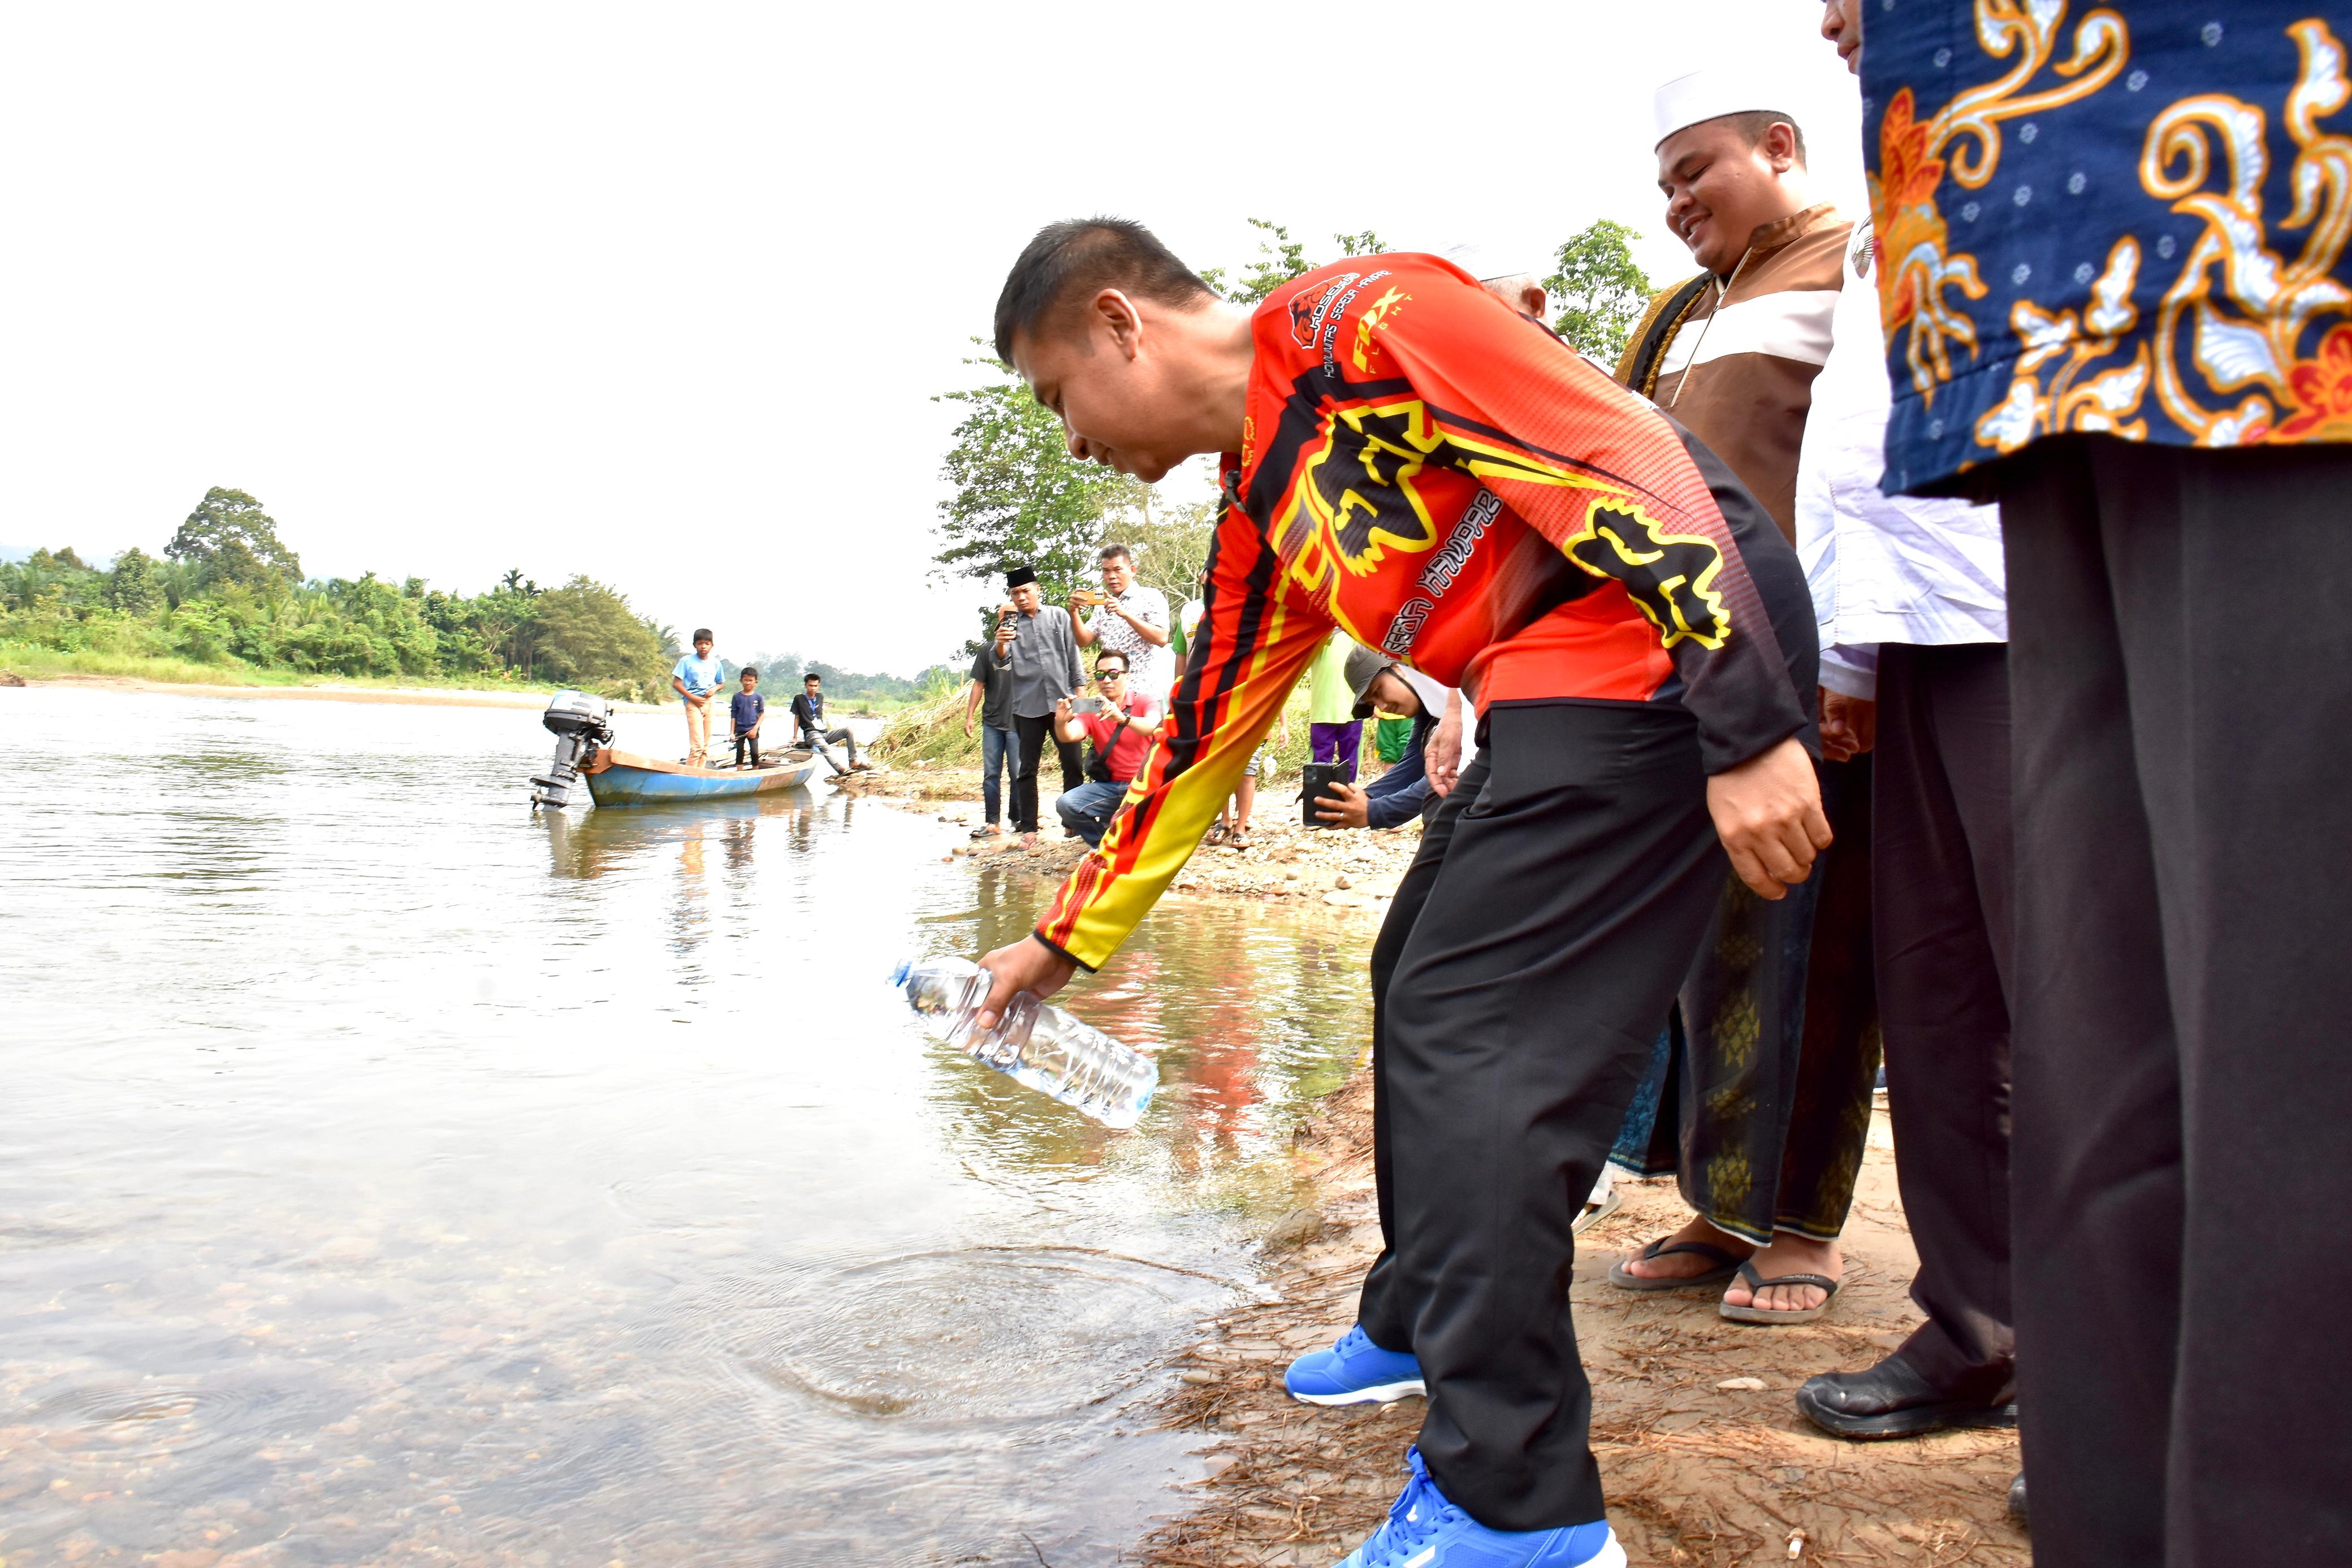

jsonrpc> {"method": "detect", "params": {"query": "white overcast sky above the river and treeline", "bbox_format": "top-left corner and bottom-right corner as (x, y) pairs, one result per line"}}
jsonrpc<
(0, 0), (1863, 675)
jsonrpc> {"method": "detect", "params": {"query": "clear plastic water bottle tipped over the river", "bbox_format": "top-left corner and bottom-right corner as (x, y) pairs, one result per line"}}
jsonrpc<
(889, 959), (1160, 1128)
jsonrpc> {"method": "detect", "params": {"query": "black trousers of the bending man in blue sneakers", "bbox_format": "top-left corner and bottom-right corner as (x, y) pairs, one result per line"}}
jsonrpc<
(1367, 703), (1724, 1530)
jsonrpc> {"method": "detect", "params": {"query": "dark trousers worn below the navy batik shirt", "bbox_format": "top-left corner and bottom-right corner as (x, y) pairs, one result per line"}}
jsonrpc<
(2001, 438), (2352, 1568)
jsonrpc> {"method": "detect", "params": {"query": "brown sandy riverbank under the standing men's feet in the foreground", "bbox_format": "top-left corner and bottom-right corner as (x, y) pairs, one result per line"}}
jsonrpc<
(1136, 1072), (2032, 1568)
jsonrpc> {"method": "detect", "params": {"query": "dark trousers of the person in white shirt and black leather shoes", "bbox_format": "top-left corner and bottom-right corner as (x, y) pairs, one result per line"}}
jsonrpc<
(1872, 642), (2016, 1404)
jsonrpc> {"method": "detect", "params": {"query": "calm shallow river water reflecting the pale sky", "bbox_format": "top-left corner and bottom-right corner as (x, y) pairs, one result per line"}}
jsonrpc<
(0, 686), (1369, 1568)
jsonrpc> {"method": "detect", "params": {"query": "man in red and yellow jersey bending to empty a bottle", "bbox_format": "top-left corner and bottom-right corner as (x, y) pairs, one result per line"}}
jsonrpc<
(981, 219), (1830, 1568)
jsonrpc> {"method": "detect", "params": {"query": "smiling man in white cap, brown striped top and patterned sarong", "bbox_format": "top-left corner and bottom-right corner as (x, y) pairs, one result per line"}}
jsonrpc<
(1611, 71), (1879, 1323)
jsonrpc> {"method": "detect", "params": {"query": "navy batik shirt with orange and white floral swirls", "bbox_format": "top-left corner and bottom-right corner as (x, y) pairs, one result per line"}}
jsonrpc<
(1863, 0), (2352, 493)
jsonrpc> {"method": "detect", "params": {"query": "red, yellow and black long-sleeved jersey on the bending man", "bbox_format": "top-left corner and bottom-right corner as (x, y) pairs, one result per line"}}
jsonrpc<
(1037, 256), (1816, 968)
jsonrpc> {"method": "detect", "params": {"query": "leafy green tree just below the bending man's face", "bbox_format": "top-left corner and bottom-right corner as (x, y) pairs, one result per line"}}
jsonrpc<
(931, 345), (1143, 604)
